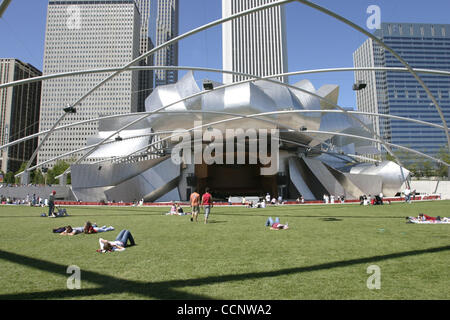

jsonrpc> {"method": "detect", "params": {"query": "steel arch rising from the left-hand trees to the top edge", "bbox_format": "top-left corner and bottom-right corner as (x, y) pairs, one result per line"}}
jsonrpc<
(23, 0), (294, 172)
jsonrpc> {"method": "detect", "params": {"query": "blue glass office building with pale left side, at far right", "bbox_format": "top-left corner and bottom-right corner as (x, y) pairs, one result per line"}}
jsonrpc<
(353, 23), (450, 160)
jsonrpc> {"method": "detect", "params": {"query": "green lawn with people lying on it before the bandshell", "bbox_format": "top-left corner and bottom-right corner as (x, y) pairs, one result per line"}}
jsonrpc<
(0, 201), (450, 300)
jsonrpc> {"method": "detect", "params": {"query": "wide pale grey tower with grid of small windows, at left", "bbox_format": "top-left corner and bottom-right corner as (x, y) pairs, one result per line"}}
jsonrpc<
(38, 0), (141, 166)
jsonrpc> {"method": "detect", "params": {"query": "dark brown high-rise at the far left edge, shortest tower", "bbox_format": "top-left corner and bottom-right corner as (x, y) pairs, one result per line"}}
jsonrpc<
(0, 59), (42, 172)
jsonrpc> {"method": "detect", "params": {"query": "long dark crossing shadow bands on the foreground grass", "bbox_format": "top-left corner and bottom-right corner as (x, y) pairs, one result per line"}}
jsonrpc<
(0, 246), (450, 300)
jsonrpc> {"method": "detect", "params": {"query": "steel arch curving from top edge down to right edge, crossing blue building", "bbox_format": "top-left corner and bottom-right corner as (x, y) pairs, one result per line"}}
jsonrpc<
(296, 0), (450, 156)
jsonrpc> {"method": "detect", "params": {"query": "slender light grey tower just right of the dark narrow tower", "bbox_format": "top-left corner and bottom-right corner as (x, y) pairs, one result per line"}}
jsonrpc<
(136, 0), (154, 112)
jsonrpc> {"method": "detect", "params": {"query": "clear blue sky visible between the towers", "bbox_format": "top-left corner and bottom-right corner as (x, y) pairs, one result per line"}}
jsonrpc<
(0, 0), (450, 108)
